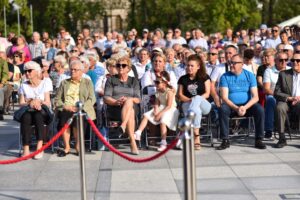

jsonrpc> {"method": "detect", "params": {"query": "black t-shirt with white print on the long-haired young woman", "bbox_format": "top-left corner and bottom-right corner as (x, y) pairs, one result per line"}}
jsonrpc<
(178, 74), (210, 98)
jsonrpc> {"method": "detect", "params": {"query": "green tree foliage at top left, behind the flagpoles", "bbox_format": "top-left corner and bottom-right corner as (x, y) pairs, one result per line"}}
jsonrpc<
(0, 0), (104, 37)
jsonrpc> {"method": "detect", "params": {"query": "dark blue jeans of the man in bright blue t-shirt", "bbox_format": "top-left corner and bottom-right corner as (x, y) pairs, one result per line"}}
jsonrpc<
(219, 103), (265, 139)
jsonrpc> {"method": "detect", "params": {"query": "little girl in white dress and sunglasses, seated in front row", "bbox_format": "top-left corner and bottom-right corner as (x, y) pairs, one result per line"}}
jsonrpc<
(135, 71), (179, 151)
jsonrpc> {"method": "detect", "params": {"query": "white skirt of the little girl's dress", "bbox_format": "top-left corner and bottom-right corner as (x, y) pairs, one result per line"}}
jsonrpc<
(144, 105), (179, 131)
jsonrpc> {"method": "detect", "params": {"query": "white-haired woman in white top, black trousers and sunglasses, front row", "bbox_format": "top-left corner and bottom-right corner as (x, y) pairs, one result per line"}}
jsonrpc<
(19, 61), (52, 159)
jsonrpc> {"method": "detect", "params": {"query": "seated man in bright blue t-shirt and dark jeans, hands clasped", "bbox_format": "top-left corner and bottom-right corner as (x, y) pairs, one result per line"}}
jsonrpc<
(217, 54), (266, 150)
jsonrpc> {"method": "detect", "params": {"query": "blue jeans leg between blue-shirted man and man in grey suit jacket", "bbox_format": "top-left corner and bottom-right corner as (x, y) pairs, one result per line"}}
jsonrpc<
(265, 95), (276, 131)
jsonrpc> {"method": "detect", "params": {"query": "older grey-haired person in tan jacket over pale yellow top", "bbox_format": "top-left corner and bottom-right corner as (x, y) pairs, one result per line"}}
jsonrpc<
(55, 60), (96, 157)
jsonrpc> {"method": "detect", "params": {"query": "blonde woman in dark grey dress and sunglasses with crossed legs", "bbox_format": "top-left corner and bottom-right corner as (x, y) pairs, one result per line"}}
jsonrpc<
(104, 56), (140, 155)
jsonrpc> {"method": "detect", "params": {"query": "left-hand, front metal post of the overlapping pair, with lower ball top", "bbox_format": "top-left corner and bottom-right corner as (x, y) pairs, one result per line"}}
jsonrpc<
(178, 119), (196, 200)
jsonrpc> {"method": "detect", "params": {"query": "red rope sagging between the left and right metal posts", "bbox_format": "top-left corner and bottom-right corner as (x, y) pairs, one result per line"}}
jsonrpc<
(87, 118), (178, 163)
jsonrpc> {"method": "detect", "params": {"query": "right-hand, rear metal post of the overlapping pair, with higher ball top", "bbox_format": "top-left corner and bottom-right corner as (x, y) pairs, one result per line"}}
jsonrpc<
(187, 111), (200, 199)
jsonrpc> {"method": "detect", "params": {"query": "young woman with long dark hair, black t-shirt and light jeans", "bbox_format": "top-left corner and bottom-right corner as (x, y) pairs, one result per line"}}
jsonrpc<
(178, 55), (211, 150)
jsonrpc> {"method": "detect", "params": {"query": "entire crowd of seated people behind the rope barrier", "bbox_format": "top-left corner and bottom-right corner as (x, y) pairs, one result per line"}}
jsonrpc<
(0, 25), (300, 157)
